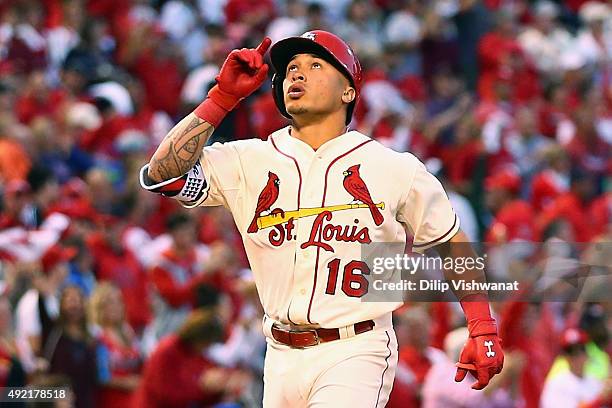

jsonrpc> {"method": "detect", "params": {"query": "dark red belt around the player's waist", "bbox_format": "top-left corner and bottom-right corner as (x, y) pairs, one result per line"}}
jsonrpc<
(272, 320), (374, 348)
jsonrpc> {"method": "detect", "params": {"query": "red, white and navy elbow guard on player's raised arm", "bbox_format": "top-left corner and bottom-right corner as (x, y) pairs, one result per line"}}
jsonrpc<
(140, 162), (209, 208)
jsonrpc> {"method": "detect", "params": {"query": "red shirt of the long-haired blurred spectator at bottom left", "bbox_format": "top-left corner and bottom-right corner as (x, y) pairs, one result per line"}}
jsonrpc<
(98, 331), (142, 407)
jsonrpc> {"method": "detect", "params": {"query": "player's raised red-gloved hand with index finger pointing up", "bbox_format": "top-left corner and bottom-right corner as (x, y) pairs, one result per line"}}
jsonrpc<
(208, 37), (272, 111)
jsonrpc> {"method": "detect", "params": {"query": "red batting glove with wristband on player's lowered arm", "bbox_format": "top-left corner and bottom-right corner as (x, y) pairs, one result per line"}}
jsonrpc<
(455, 295), (504, 390)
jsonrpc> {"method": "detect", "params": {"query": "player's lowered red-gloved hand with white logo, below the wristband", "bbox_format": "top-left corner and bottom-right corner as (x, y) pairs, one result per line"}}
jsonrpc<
(455, 319), (504, 390)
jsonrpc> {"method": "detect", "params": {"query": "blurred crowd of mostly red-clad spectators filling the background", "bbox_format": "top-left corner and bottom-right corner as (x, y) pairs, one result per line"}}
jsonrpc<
(0, 0), (612, 407)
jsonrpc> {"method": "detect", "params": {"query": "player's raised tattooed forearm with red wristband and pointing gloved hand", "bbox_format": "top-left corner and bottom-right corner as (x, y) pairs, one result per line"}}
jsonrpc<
(147, 38), (271, 182)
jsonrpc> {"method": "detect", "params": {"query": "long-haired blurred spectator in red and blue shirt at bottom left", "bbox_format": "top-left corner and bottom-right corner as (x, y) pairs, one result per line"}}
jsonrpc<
(89, 282), (142, 407)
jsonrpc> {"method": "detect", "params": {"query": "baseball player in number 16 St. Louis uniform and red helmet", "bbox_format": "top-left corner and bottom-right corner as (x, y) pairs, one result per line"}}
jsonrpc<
(140, 31), (503, 408)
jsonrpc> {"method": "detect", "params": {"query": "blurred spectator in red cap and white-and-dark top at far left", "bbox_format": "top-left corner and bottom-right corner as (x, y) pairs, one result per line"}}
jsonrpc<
(15, 245), (77, 372)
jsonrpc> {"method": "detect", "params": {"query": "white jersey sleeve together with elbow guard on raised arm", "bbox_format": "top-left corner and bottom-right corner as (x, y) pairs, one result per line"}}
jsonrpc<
(140, 142), (242, 208)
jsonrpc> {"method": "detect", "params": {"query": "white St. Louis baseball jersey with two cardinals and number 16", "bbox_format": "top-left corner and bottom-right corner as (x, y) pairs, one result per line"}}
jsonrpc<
(143, 127), (459, 328)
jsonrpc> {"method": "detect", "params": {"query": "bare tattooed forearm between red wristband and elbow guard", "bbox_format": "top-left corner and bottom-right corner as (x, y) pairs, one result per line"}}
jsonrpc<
(148, 113), (215, 182)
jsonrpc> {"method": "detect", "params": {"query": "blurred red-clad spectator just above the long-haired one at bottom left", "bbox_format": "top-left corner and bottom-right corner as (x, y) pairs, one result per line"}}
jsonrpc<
(87, 213), (151, 333)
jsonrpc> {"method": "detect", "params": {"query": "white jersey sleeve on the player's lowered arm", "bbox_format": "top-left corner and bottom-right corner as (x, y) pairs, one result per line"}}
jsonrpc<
(398, 157), (459, 252)
